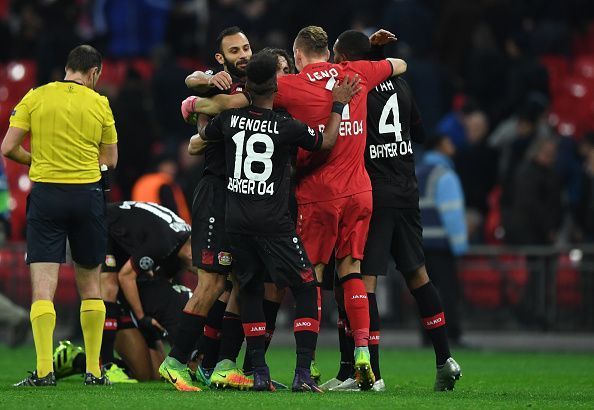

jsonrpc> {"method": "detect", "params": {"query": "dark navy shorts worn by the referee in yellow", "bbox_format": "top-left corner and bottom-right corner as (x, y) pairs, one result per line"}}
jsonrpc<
(27, 182), (107, 267)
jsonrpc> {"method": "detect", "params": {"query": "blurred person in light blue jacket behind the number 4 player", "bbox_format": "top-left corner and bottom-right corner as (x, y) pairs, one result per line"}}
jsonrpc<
(417, 135), (468, 346)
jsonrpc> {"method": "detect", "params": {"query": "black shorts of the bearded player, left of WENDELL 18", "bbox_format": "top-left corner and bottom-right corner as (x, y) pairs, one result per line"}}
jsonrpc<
(192, 175), (233, 275)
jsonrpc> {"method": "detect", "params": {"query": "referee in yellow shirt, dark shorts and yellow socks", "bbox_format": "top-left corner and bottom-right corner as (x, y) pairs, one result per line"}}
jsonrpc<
(2, 45), (117, 386)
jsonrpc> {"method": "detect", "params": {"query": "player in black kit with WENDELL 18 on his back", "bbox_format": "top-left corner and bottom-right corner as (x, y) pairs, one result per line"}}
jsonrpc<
(201, 52), (359, 392)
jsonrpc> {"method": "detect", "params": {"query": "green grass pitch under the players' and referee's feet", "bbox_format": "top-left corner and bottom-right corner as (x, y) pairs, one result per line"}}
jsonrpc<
(0, 347), (594, 410)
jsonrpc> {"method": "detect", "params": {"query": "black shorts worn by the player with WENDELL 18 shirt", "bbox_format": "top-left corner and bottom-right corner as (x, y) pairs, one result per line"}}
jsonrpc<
(229, 233), (316, 288)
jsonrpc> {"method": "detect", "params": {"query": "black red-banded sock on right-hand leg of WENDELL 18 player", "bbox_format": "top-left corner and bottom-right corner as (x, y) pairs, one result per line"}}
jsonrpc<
(291, 285), (320, 370)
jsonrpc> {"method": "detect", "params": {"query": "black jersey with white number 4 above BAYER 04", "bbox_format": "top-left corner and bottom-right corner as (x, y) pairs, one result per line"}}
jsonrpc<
(365, 76), (425, 208)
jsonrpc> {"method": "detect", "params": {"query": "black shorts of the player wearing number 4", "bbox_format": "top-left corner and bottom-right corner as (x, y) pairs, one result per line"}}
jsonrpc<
(361, 208), (425, 276)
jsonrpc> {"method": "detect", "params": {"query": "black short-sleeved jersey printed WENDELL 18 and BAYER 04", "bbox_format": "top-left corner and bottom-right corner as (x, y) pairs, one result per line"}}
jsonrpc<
(205, 106), (324, 236)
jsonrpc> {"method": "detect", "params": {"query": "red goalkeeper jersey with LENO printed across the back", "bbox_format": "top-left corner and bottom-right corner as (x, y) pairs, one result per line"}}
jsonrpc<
(274, 60), (392, 204)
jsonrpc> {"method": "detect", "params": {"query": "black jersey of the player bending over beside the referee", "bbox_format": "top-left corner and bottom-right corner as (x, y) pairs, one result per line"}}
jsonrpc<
(106, 201), (191, 277)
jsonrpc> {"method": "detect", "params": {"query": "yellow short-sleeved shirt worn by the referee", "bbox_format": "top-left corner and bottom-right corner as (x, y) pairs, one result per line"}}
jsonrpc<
(10, 81), (118, 184)
